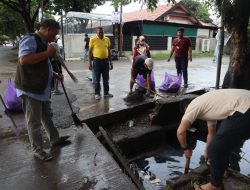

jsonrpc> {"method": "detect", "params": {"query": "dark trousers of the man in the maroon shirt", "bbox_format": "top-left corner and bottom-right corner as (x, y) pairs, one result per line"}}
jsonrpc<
(175, 57), (188, 84)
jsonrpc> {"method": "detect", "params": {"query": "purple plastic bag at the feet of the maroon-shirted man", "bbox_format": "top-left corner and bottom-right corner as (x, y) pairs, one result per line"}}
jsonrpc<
(159, 72), (182, 93)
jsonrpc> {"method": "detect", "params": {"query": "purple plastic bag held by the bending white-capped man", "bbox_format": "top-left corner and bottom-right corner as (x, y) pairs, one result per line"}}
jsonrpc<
(135, 71), (155, 93)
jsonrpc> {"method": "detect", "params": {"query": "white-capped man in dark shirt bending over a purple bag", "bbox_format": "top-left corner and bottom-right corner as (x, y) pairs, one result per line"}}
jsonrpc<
(130, 55), (154, 94)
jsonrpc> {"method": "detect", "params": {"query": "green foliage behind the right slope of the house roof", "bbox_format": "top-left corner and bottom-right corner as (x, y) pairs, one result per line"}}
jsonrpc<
(182, 0), (212, 23)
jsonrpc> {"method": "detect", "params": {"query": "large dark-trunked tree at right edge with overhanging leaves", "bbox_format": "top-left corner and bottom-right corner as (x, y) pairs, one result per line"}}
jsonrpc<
(136, 0), (250, 90)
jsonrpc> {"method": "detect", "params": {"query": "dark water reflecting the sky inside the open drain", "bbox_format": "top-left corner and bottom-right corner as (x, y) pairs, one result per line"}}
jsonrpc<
(132, 140), (250, 190)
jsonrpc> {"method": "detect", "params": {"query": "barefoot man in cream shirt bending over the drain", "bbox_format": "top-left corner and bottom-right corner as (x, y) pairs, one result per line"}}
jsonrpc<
(177, 89), (250, 190)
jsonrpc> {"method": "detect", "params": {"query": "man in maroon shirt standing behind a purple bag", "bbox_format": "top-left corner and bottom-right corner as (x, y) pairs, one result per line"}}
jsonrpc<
(168, 27), (192, 88)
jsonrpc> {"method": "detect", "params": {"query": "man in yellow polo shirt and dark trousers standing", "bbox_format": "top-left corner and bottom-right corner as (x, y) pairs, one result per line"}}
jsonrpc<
(89, 27), (113, 100)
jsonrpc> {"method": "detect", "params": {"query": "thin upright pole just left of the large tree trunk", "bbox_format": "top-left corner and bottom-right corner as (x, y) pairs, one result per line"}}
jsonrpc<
(215, 0), (225, 89)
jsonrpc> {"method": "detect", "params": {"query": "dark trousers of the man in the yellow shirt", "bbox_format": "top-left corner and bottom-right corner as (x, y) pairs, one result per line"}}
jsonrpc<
(93, 58), (109, 95)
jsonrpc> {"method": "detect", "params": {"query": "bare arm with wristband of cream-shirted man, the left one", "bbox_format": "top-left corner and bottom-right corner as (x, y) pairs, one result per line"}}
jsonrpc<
(177, 120), (192, 158)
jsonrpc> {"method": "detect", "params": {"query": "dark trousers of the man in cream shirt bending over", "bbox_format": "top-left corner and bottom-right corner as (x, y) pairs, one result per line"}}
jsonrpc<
(208, 109), (250, 187)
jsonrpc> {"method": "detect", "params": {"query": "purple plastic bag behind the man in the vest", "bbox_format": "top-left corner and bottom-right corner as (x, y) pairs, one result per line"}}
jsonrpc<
(3, 78), (23, 112)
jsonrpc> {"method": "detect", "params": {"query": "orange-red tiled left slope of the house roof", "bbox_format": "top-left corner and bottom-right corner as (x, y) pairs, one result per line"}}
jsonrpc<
(122, 3), (173, 22)
